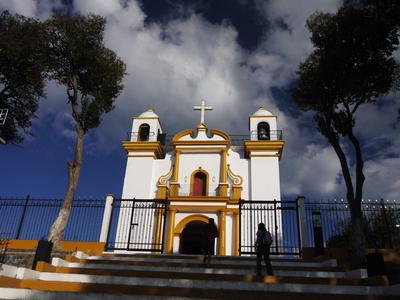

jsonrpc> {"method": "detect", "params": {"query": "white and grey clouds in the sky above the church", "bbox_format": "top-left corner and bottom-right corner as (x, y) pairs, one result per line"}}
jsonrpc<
(0, 0), (400, 202)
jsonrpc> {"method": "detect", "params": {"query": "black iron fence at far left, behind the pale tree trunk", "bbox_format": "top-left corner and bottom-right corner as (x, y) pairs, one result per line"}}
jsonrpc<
(0, 196), (105, 241)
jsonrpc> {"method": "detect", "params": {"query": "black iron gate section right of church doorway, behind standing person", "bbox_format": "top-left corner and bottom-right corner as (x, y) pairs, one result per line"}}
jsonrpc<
(239, 200), (301, 255)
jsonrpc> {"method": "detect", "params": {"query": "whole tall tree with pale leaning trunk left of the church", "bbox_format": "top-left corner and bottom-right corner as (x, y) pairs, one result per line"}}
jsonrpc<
(46, 15), (125, 249)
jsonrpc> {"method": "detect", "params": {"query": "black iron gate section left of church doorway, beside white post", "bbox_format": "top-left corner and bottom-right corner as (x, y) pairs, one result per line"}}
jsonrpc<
(106, 199), (169, 253)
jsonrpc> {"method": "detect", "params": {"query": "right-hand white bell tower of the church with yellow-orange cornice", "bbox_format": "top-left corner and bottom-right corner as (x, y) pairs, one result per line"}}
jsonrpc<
(245, 107), (285, 200)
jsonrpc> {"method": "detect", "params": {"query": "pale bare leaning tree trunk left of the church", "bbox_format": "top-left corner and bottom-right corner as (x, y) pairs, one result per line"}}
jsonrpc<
(48, 124), (85, 250)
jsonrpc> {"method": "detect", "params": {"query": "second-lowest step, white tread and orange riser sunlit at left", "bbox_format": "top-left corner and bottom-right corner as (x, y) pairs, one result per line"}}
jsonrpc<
(0, 268), (400, 299)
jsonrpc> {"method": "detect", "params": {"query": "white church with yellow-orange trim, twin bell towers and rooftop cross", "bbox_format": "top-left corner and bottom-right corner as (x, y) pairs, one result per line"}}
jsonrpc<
(116, 101), (284, 255)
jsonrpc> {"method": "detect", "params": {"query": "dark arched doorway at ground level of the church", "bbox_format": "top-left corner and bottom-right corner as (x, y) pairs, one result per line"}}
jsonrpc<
(179, 220), (207, 254)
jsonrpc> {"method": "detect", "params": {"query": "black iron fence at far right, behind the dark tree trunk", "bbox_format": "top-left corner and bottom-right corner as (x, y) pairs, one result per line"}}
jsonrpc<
(305, 199), (400, 249)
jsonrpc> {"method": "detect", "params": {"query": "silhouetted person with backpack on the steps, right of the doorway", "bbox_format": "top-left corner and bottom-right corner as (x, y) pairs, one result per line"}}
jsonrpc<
(255, 223), (273, 276)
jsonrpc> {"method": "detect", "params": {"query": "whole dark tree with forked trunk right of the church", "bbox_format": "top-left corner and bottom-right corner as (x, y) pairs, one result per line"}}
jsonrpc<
(291, 0), (399, 264)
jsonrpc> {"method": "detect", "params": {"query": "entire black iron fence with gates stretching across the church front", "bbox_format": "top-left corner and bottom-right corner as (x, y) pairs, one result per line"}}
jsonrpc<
(0, 194), (400, 254)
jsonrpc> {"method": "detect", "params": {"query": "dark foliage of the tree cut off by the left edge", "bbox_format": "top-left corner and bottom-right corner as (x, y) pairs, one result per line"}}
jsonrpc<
(0, 11), (47, 143)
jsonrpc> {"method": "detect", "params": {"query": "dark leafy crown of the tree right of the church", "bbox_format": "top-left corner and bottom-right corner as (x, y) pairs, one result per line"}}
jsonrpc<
(292, 6), (399, 135)
